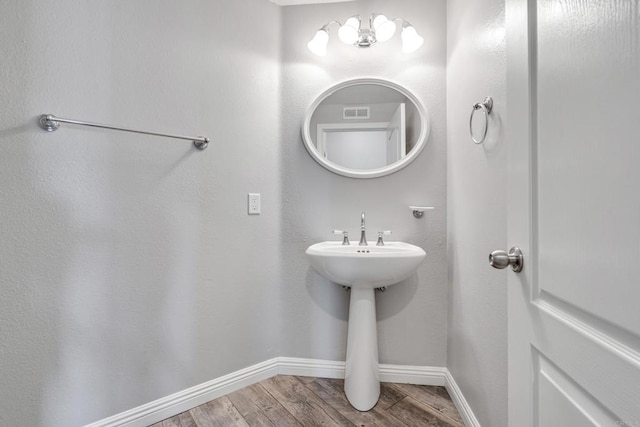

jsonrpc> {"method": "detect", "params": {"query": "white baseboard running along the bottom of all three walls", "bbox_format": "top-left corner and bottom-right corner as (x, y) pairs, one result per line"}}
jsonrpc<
(86, 357), (480, 427)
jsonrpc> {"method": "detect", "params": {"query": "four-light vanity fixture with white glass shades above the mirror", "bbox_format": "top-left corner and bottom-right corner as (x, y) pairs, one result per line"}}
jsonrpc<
(307, 13), (424, 56)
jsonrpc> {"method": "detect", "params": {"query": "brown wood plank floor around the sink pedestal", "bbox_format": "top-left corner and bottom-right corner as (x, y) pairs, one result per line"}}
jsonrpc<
(152, 375), (464, 427)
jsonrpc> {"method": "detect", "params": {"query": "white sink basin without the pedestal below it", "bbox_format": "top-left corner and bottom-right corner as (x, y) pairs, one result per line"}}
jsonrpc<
(306, 241), (426, 288)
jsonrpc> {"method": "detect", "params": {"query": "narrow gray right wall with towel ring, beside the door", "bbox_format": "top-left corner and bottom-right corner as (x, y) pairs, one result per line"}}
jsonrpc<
(447, 0), (508, 427)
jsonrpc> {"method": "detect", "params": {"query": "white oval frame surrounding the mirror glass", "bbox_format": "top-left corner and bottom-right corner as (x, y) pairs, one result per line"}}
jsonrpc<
(302, 78), (430, 178)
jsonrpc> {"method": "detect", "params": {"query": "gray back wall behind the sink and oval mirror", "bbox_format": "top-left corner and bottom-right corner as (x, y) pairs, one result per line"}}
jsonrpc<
(280, 0), (447, 366)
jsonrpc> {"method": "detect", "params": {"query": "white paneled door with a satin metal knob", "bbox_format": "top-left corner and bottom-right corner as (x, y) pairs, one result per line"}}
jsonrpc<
(505, 0), (640, 427)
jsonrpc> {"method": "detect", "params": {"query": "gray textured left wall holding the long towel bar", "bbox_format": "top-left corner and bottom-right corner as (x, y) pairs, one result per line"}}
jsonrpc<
(0, 0), (281, 426)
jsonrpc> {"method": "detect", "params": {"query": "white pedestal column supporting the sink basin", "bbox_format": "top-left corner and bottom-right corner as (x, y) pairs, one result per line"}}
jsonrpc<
(344, 286), (380, 411)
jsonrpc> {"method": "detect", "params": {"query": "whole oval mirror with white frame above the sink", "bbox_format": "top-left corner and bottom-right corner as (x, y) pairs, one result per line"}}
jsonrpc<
(302, 79), (429, 178)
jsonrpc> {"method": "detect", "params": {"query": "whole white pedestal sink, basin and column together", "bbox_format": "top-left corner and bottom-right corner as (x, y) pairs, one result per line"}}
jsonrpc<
(306, 242), (426, 411)
